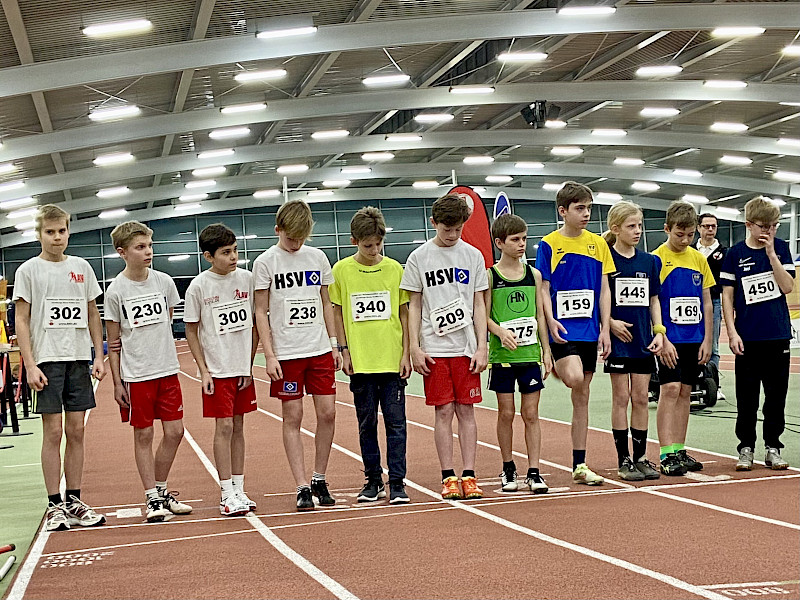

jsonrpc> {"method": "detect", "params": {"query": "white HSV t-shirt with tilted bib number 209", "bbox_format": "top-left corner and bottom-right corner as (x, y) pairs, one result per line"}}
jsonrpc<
(400, 240), (489, 357)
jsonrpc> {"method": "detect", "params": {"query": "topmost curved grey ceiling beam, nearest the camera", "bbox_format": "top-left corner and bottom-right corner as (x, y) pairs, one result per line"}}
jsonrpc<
(0, 2), (800, 97)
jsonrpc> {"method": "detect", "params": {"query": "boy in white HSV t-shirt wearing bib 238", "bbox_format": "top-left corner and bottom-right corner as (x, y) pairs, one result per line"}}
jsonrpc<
(253, 200), (342, 511)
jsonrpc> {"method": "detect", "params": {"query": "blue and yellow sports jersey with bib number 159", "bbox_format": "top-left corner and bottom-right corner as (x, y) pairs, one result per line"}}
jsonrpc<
(536, 229), (615, 342)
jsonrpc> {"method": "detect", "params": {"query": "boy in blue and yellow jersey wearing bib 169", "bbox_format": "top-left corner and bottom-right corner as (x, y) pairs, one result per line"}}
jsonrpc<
(653, 201), (714, 475)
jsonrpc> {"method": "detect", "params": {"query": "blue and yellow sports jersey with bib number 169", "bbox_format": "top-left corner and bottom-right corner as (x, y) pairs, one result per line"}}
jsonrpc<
(653, 244), (716, 344)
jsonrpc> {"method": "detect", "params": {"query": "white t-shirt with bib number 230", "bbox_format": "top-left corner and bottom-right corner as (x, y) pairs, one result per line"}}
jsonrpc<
(103, 269), (181, 382)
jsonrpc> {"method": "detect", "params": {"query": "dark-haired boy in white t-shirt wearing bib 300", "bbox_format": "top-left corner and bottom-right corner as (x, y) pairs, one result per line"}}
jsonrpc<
(183, 223), (258, 517)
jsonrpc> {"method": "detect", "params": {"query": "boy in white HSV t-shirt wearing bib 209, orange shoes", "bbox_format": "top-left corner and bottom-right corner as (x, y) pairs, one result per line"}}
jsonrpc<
(400, 194), (489, 499)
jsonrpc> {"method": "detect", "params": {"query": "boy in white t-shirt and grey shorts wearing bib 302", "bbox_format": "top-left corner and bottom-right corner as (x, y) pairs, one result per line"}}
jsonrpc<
(13, 204), (106, 531)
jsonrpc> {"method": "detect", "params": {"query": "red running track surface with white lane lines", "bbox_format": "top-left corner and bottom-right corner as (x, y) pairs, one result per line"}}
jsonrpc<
(3, 342), (800, 599)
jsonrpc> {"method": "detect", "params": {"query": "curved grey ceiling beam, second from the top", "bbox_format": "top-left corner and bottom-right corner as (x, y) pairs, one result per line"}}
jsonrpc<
(0, 81), (797, 162)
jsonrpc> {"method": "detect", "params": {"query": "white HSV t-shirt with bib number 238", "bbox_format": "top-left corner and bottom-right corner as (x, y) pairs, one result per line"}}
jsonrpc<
(253, 244), (333, 360)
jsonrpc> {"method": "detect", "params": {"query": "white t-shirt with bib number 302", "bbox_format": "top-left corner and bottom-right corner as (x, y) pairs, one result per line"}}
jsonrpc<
(13, 256), (102, 363)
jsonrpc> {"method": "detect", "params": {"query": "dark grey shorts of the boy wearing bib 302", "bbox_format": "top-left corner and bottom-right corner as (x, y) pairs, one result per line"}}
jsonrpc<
(31, 360), (95, 415)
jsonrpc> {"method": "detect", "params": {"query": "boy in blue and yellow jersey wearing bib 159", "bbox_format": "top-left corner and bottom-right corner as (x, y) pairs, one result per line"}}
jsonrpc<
(536, 181), (615, 485)
